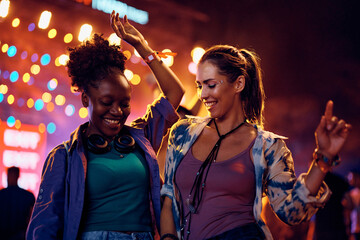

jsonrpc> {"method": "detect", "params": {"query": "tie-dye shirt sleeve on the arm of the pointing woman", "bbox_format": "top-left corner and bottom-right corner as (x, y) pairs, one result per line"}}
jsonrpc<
(265, 139), (331, 225)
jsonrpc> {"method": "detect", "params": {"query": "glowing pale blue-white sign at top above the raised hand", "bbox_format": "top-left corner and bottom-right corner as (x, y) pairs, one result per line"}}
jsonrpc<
(92, 0), (149, 24)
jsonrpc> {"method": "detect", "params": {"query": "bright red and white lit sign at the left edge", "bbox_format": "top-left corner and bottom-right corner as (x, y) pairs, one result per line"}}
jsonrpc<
(0, 123), (46, 196)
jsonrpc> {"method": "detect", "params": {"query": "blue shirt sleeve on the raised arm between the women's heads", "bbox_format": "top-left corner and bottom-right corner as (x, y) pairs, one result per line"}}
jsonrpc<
(131, 94), (179, 152)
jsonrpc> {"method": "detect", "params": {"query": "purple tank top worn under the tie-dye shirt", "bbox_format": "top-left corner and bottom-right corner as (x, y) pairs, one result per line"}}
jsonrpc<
(175, 140), (255, 240)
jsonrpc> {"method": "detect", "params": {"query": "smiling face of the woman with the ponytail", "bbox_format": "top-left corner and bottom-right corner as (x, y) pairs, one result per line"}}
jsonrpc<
(196, 61), (243, 118)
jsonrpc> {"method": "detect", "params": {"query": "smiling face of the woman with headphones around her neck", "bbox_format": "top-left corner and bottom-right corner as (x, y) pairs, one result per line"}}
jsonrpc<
(82, 72), (131, 140)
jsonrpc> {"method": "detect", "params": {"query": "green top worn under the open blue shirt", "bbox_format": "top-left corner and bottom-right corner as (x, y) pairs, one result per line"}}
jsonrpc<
(82, 142), (152, 232)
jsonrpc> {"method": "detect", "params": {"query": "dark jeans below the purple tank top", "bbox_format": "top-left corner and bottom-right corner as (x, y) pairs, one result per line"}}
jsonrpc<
(207, 223), (265, 240)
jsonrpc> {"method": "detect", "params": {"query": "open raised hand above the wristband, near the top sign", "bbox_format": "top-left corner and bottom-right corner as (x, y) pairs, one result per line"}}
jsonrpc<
(110, 11), (145, 47)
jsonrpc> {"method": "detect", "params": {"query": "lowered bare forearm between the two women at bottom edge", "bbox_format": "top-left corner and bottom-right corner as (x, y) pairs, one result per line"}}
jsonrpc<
(160, 197), (177, 240)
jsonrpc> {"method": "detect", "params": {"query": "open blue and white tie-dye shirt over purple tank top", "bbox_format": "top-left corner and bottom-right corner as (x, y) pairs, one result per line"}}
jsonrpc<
(161, 117), (331, 239)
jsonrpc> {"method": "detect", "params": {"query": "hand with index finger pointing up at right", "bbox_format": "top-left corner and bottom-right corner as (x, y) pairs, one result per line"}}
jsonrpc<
(315, 100), (351, 159)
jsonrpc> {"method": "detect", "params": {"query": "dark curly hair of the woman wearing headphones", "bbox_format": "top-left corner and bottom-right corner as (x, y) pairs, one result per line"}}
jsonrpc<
(66, 33), (126, 92)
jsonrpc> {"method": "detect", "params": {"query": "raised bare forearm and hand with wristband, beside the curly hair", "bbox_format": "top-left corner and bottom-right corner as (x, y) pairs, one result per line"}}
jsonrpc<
(110, 11), (184, 109)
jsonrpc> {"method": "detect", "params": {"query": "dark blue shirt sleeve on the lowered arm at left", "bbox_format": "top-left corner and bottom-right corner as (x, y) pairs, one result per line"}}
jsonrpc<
(26, 146), (66, 240)
